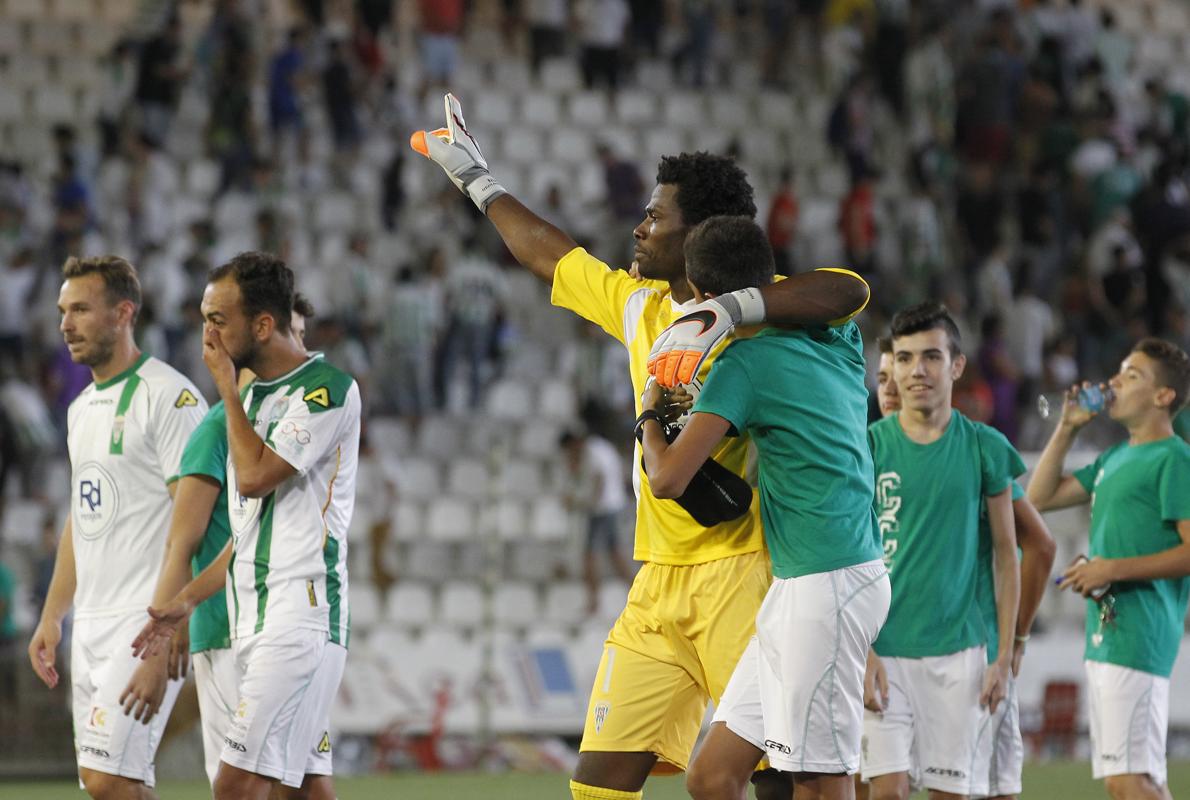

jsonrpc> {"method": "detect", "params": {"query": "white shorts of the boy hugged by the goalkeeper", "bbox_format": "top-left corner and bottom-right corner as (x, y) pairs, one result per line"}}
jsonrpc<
(714, 561), (891, 773)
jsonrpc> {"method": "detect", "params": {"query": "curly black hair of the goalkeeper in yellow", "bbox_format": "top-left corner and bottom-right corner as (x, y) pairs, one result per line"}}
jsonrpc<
(657, 152), (756, 225)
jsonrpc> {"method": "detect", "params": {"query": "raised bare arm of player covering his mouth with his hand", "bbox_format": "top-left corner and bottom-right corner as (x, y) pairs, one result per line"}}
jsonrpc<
(202, 326), (298, 498)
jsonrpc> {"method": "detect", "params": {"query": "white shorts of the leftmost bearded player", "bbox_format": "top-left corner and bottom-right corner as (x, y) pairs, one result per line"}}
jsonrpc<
(70, 611), (182, 787)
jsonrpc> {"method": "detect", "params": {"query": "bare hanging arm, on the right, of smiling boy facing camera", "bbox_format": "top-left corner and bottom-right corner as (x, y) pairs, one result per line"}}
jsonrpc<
(979, 488), (1021, 712)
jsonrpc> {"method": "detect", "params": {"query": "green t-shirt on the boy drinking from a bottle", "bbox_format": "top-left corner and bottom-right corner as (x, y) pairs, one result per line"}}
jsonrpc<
(1075, 436), (1190, 677)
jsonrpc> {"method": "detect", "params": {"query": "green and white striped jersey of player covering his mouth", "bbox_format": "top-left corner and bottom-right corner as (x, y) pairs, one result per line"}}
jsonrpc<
(227, 354), (361, 646)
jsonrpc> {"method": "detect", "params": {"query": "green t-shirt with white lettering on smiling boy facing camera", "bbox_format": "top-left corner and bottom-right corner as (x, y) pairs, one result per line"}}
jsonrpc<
(868, 411), (1025, 658)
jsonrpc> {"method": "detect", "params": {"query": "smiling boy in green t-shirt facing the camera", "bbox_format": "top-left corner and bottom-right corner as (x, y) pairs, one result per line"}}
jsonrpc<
(863, 302), (1025, 796)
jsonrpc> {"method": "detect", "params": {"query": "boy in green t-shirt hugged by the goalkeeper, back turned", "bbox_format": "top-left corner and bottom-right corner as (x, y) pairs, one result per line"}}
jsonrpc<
(637, 217), (891, 798)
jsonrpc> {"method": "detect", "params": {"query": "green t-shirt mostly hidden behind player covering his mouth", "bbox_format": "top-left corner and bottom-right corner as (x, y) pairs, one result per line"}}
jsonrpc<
(179, 401), (231, 652)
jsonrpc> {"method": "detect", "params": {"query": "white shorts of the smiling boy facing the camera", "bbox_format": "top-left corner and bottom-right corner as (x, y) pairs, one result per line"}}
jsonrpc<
(862, 645), (990, 796)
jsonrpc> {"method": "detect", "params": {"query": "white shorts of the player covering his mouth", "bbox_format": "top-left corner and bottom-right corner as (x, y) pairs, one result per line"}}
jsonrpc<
(220, 629), (346, 787)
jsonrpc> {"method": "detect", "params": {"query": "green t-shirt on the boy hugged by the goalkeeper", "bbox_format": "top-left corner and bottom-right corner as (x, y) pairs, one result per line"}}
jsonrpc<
(694, 323), (881, 577)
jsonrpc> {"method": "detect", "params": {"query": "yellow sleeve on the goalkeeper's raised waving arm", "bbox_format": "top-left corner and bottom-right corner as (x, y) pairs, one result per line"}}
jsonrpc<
(550, 248), (655, 345)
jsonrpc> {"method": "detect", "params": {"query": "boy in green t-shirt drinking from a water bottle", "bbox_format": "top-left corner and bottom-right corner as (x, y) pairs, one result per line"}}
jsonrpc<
(1029, 338), (1190, 798)
